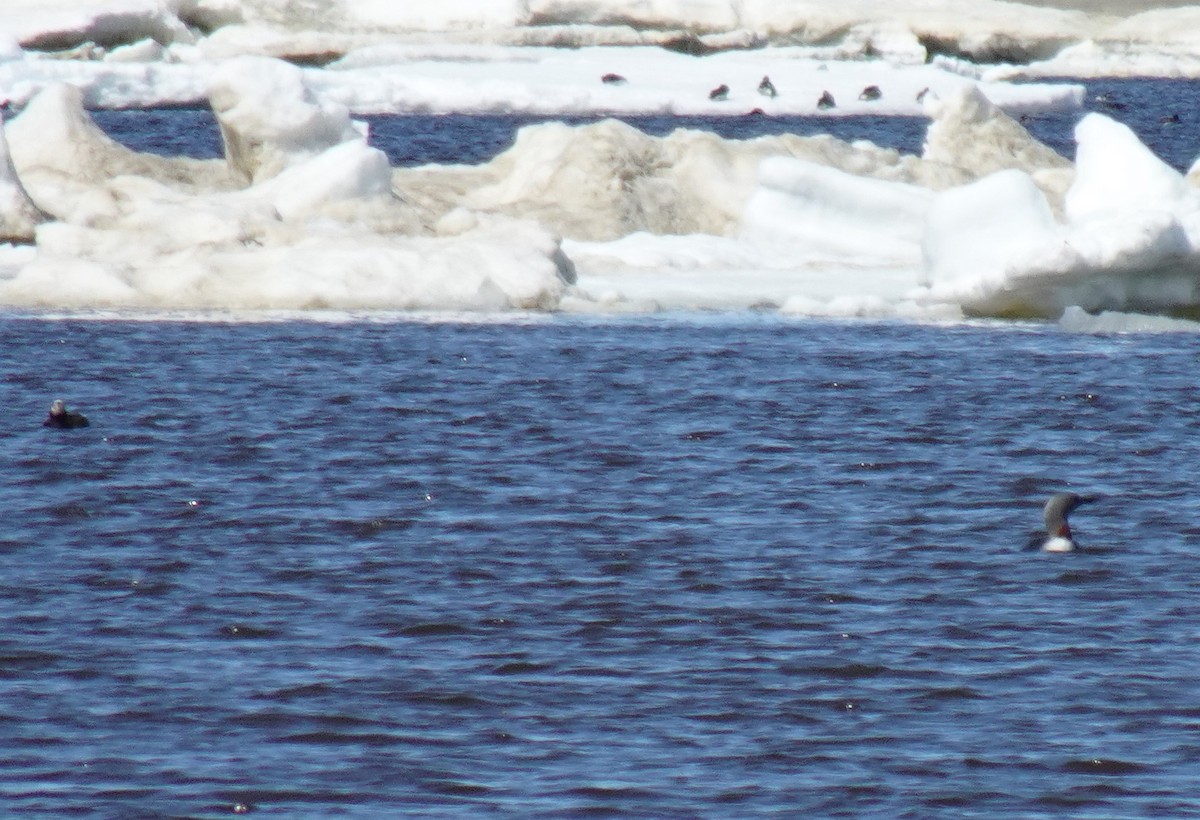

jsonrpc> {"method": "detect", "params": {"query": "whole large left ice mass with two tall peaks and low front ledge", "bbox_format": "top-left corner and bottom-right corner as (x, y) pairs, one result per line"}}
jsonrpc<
(0, 61), (574, 310)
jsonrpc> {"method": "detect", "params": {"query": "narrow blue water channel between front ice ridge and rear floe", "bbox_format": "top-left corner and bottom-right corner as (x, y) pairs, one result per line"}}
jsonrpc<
(92, 79), (1200, 170)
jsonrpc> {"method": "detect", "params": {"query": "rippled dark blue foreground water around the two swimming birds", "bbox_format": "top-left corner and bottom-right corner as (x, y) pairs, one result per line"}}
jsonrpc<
(7, 316), (1200, 818)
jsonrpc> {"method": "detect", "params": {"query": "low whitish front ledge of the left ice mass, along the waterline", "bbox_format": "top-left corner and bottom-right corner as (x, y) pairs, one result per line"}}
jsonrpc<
(0, 211), (569, 311)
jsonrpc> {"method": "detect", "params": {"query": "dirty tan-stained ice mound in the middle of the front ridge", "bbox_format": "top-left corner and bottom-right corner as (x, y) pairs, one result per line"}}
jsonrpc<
(412, 120), (941, 240)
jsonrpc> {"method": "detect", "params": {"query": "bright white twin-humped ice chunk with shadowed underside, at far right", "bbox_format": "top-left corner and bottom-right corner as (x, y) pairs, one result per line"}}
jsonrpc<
(924, 121), (1200, 318)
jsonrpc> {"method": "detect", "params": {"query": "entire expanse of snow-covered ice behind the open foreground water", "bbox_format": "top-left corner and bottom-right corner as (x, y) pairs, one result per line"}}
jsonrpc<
(0, 0), (1200, 330)
